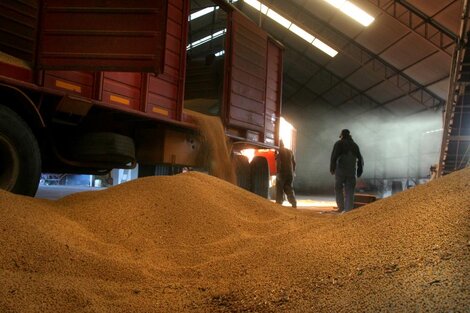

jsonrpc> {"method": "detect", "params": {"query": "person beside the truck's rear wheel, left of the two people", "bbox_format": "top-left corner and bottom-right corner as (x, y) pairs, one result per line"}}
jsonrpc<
(276, 140), (297, 208)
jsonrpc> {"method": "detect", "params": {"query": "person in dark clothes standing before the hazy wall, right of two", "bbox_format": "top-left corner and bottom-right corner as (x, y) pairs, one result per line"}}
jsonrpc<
(330, 129), (364, 213)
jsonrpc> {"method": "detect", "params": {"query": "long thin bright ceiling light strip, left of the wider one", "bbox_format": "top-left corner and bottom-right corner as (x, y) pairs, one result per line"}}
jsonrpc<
(243, 0), (340, 57)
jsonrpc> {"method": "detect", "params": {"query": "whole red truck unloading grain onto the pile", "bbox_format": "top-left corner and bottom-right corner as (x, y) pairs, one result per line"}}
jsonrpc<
(0, 0), (282, 196)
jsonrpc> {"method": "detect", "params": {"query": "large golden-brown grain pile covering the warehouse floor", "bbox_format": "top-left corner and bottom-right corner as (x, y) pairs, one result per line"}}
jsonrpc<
(0, 169), (470, 313)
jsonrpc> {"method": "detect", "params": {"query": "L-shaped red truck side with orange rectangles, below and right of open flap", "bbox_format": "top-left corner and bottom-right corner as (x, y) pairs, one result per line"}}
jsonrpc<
(39, 0), (188, 121)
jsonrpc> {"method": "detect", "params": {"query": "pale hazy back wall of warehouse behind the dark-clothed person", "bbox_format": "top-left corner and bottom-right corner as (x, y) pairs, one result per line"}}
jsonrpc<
(283, 92), (442, 194)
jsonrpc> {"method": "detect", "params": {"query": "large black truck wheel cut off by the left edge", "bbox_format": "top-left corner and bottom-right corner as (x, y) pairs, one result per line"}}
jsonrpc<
(0, 105), (41, 196)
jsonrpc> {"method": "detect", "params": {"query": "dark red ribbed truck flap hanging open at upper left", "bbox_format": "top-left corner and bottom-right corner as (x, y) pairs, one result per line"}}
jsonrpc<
(39, 0), (166, 73)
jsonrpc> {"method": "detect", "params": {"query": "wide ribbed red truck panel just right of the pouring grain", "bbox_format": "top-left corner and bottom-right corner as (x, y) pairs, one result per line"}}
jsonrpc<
(226, 11), (267, 132)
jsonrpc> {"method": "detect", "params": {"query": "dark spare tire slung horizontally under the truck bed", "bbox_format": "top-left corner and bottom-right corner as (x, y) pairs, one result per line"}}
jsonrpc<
(70, 132), (135, 165)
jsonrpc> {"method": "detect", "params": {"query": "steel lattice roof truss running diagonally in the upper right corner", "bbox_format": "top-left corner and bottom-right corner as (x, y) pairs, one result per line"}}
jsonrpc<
(369, 0), (457, 56)
